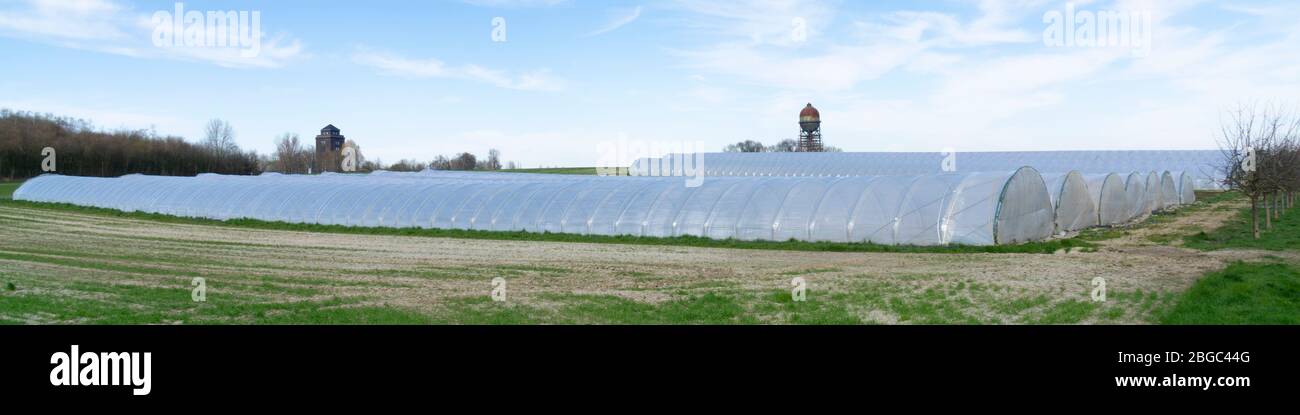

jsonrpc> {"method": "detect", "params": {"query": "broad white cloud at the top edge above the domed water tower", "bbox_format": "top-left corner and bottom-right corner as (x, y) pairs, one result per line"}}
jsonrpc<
(677, 0), (1041, 92)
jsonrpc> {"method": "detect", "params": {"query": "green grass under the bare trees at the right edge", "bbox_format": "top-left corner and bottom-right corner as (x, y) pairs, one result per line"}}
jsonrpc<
(1183, 197), (1300, 251)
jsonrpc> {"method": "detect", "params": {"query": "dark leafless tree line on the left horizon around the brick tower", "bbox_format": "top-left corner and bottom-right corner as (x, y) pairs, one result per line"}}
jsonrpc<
(0, 109), (517, 180)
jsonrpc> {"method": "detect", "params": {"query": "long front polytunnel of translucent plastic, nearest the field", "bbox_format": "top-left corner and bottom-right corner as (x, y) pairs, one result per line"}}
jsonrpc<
(14, 168), (1053, 245)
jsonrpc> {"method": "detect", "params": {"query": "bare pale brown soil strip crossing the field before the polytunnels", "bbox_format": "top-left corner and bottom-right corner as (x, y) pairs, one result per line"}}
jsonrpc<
(0, 197), (1278, 324)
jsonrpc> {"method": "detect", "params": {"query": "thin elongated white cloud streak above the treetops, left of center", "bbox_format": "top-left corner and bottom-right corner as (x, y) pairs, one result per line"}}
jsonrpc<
(352, 49), (566, 91)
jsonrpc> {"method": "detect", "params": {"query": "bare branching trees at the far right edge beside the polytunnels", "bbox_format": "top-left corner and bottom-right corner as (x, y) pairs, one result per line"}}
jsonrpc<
(1218, 104), (1300, 239)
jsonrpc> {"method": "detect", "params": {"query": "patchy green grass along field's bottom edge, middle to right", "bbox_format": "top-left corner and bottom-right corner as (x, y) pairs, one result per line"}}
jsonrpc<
(418, 281), (1107, 325)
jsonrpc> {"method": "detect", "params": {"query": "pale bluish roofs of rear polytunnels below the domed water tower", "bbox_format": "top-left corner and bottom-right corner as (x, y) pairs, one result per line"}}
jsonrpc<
(631, 150), (1223, 189)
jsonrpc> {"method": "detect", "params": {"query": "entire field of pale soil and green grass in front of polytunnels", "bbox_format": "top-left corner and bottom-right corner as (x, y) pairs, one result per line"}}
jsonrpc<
(0, 189), (1300, 324)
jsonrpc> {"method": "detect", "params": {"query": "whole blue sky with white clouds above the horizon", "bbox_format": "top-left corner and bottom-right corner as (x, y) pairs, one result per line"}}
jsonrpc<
(0, 0), (1300, 167)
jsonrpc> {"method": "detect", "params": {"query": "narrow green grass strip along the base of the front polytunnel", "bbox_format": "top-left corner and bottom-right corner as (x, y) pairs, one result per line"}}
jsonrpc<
(0, 200), (1096, 254)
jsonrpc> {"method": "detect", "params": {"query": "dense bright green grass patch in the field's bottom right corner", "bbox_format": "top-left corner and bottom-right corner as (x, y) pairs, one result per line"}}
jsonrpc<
(1161, 261), (1300, 324)
